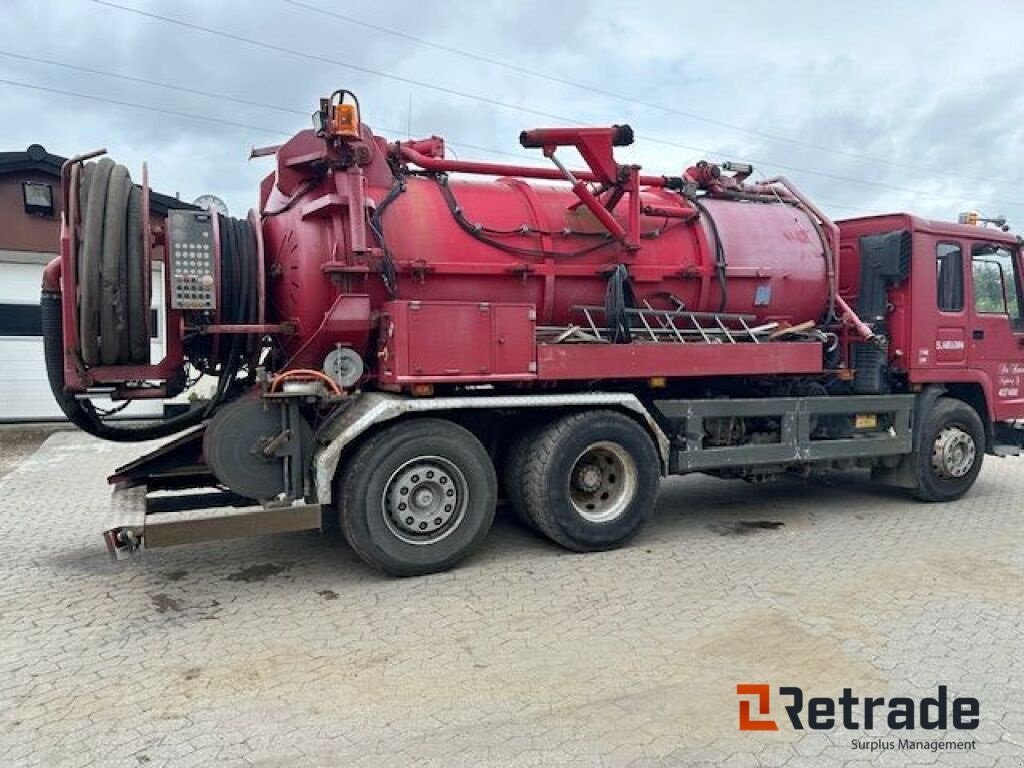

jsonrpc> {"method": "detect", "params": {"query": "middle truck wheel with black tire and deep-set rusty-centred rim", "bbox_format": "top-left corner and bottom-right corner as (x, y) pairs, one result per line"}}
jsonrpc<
(522, 411), (660, 552)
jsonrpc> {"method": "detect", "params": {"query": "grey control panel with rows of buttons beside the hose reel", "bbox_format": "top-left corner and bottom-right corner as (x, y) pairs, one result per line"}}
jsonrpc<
(167, 211), (217, 310)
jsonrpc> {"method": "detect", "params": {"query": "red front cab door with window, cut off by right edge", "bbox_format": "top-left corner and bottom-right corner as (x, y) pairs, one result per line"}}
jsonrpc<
(969, 242), (1024, 420)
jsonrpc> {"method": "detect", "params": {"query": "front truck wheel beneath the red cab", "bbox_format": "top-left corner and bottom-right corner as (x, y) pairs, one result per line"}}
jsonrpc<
(911, 397), (985, 502)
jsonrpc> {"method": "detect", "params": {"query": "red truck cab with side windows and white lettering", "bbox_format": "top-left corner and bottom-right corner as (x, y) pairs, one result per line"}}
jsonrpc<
(838, 214), (1024, 444)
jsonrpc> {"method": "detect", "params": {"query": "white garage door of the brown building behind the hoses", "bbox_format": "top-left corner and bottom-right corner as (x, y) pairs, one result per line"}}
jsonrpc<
(0, 263), (164, 421)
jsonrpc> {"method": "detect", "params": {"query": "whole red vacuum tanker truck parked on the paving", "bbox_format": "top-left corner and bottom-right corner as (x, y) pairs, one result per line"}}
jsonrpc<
(42, 90), (1024, 575)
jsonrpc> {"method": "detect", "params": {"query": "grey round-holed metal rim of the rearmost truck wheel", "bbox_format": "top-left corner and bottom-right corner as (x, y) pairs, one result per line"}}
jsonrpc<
(381, 456), (469, 545)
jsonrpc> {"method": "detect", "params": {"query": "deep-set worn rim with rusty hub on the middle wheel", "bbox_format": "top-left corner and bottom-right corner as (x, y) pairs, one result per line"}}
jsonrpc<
(569, 440), (638, 523)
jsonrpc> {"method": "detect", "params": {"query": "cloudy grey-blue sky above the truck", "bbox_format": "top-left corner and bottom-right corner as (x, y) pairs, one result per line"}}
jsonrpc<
(0, 0), (1024, 229)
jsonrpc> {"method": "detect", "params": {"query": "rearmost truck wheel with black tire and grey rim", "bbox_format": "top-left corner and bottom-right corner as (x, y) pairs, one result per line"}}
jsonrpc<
(337, 419), (498, 577)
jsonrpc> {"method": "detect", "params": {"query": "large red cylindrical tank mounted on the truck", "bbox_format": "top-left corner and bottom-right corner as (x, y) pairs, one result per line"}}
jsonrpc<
(263, 132), (828, 367)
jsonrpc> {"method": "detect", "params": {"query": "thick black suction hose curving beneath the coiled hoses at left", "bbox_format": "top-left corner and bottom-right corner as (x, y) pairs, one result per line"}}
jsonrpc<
(39, 291), (206, 442)
